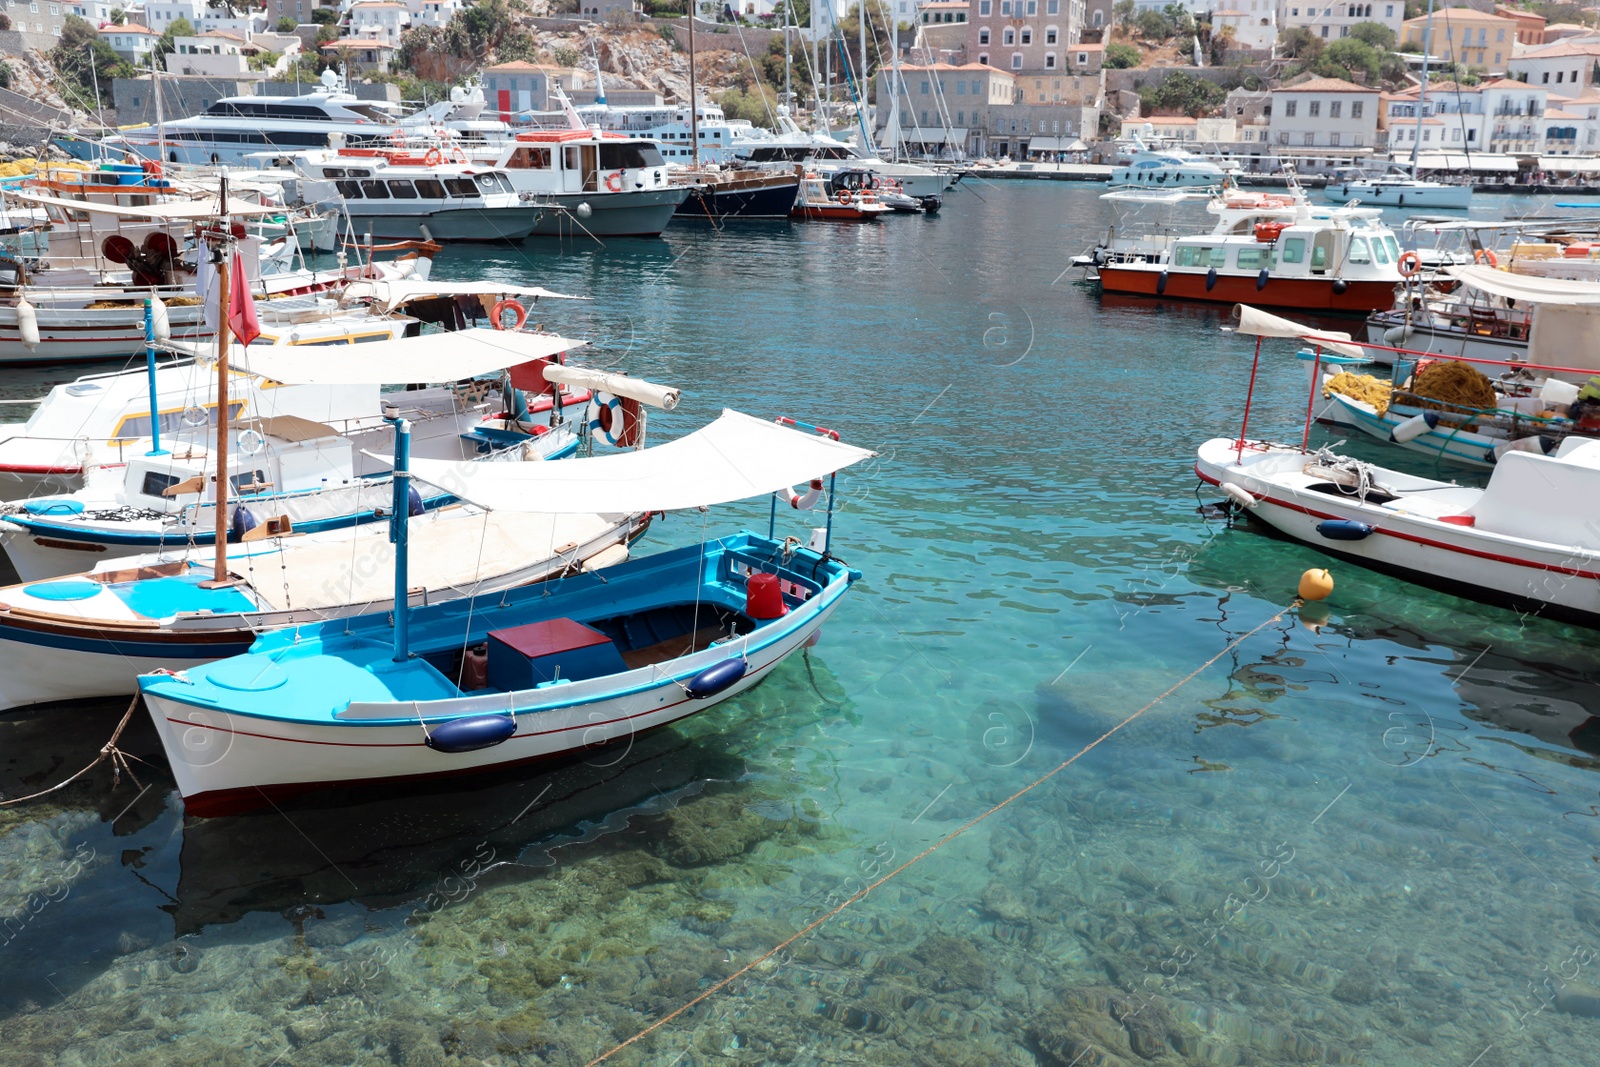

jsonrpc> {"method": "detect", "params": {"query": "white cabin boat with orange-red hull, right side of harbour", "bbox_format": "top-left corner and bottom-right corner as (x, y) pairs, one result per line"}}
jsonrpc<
(1077, 179), (1402, 312)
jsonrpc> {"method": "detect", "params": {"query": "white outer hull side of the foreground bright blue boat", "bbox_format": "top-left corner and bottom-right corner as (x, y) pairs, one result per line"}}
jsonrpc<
(144, 590), (842, 814)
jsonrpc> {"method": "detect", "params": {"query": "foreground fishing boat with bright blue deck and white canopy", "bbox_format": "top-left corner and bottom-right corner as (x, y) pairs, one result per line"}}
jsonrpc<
(139, 411), (874, 816)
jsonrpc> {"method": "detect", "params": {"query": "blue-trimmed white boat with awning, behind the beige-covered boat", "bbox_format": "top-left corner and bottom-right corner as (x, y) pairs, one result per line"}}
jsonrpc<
(0, 328), (590, 581)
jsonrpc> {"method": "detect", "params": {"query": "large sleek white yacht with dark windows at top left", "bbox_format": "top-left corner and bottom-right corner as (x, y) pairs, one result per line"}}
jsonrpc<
(109, 70), (443, 166)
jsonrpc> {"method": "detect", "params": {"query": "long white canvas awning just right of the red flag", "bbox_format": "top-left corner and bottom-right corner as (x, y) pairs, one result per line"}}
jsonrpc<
(233, 326), (585, 390)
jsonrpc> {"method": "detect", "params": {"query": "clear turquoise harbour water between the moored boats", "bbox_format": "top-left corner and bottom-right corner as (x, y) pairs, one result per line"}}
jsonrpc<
(0, 182), (1600, 1067)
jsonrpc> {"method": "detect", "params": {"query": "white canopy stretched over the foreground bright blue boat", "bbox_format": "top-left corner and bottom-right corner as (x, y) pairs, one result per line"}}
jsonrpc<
(400, 411), (877, 515)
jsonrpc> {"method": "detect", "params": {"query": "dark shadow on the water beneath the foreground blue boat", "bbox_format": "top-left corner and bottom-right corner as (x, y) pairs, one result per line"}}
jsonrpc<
(0, 699), (746, 1017)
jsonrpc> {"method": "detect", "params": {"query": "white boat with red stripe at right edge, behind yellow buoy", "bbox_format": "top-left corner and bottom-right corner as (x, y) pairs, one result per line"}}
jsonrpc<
(1195, 437), (1600, 625)
